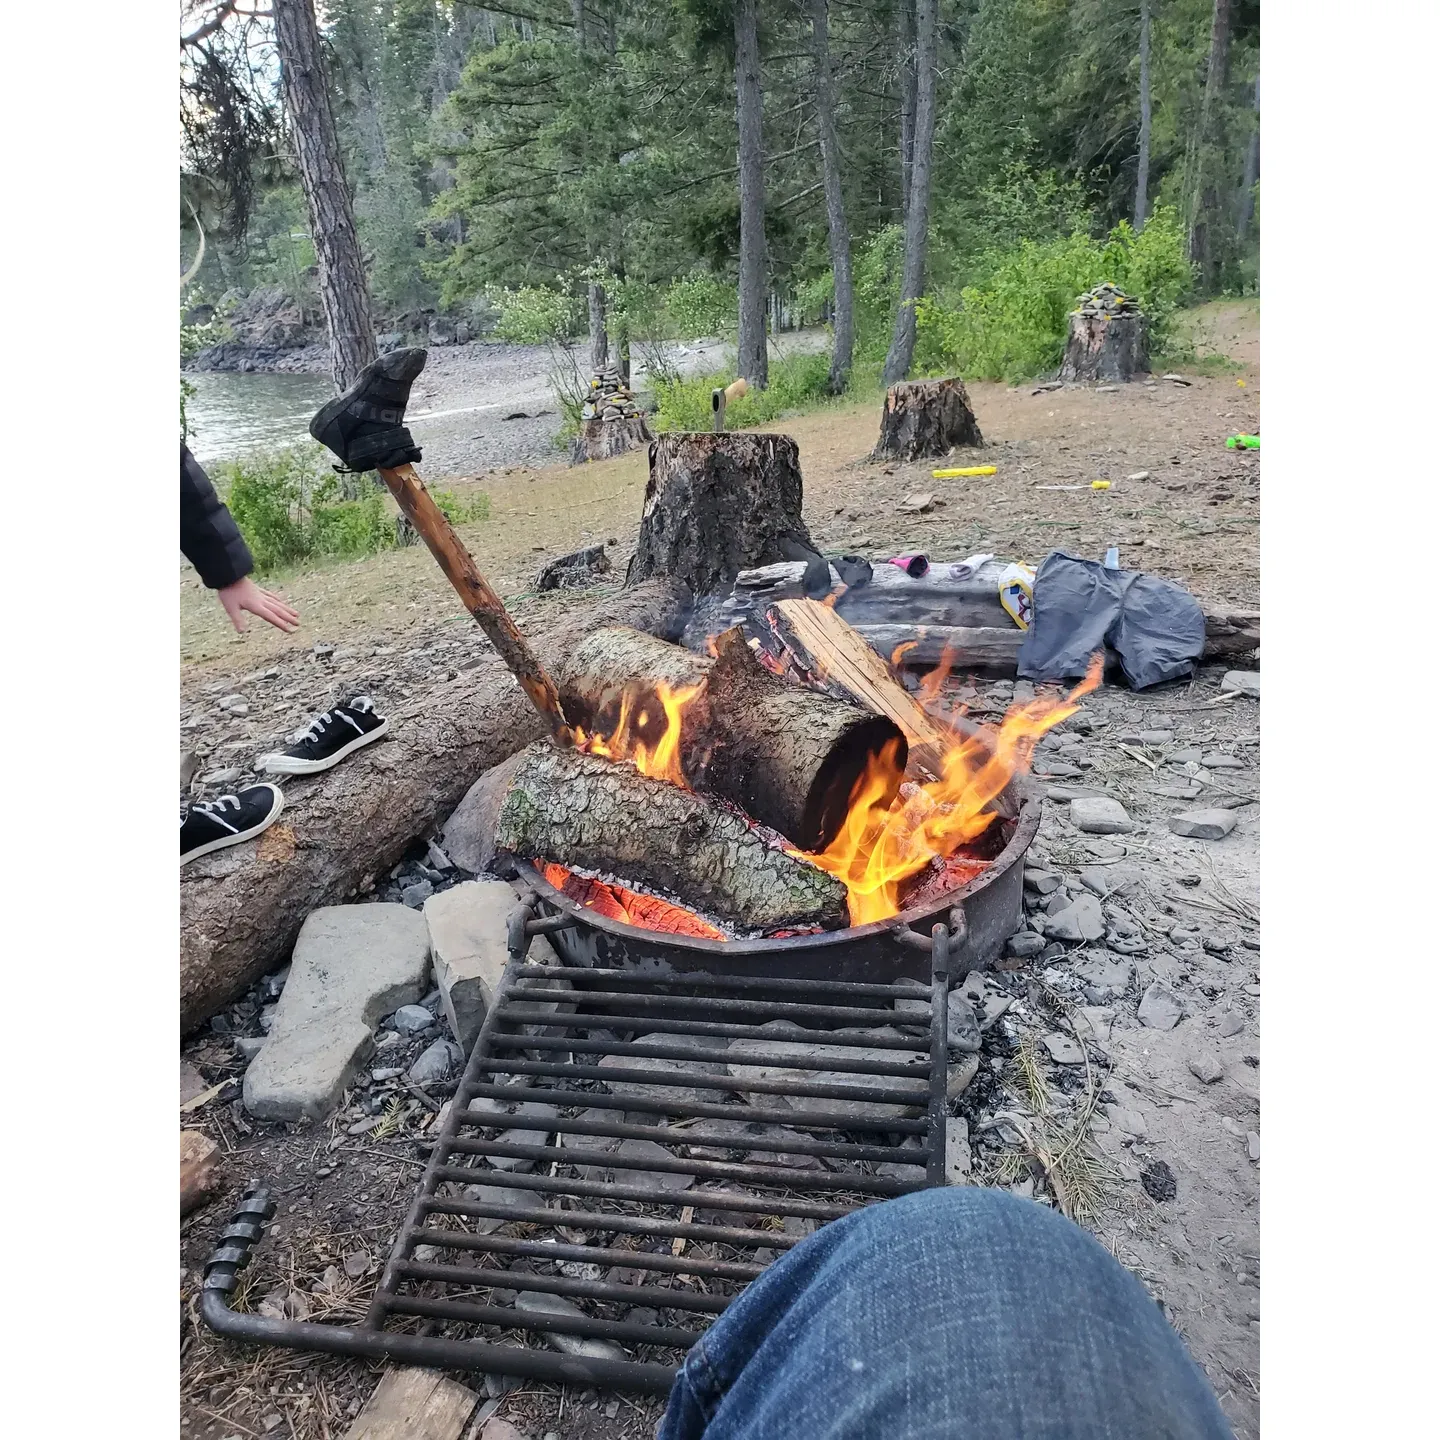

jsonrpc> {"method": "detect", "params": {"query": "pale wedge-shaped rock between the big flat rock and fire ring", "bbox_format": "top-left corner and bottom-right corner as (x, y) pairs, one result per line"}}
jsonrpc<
(425, 880), (524, 1050)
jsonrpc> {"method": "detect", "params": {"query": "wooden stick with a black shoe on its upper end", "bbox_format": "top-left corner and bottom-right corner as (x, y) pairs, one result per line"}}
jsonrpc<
(310, 348), (573, 744)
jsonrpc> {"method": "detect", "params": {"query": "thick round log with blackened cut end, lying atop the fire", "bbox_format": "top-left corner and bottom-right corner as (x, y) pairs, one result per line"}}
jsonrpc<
(554, 626), (906, 850)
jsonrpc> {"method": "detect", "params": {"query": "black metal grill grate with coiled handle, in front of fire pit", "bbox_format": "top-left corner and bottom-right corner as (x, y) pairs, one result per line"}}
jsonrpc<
(204, 922), (948, 1391)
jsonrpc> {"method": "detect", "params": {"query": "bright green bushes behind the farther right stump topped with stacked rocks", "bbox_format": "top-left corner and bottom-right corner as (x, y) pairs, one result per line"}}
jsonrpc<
(914, 209), (1192, 380)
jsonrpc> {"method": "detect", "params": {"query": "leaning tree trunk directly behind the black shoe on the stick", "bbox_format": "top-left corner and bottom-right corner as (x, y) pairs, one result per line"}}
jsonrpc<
(274, 0), (376, 390)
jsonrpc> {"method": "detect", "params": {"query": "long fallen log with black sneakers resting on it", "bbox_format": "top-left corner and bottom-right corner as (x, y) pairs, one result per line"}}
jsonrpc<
(180, 580), (690, 1032)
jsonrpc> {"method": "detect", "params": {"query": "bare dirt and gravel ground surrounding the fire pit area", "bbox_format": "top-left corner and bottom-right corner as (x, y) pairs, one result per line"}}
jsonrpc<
(181, 304), (1260, 1440)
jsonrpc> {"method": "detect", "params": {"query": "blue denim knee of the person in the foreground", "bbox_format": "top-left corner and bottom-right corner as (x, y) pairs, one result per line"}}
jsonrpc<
(657, 1187), (1231, 1440)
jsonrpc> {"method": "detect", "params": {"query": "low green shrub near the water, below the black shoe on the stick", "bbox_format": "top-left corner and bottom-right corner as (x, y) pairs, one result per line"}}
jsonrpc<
(215, 445), (396, 575)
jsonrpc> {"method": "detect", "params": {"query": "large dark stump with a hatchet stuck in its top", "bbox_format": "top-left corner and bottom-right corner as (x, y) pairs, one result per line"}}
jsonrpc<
(625, 432), (818, 596)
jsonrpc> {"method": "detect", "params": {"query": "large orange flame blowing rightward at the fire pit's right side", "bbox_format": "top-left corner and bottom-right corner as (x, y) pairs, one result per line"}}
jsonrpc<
(806, 655), (1103, 924)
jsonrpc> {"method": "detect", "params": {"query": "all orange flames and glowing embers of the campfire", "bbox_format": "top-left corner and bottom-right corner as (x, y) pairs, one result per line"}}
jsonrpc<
(527, 636), (1100, 940)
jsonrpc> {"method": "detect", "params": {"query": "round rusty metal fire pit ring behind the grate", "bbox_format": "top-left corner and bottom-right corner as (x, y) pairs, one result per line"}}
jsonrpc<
(516, 778), (1040, 984)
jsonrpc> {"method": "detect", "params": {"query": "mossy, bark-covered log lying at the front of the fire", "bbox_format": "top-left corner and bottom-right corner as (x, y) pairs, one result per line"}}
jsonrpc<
(495, 744), (850, 930)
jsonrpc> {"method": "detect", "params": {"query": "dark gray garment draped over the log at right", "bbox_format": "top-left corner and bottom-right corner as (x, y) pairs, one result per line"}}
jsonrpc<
(1017, 550), (1205, 690)
